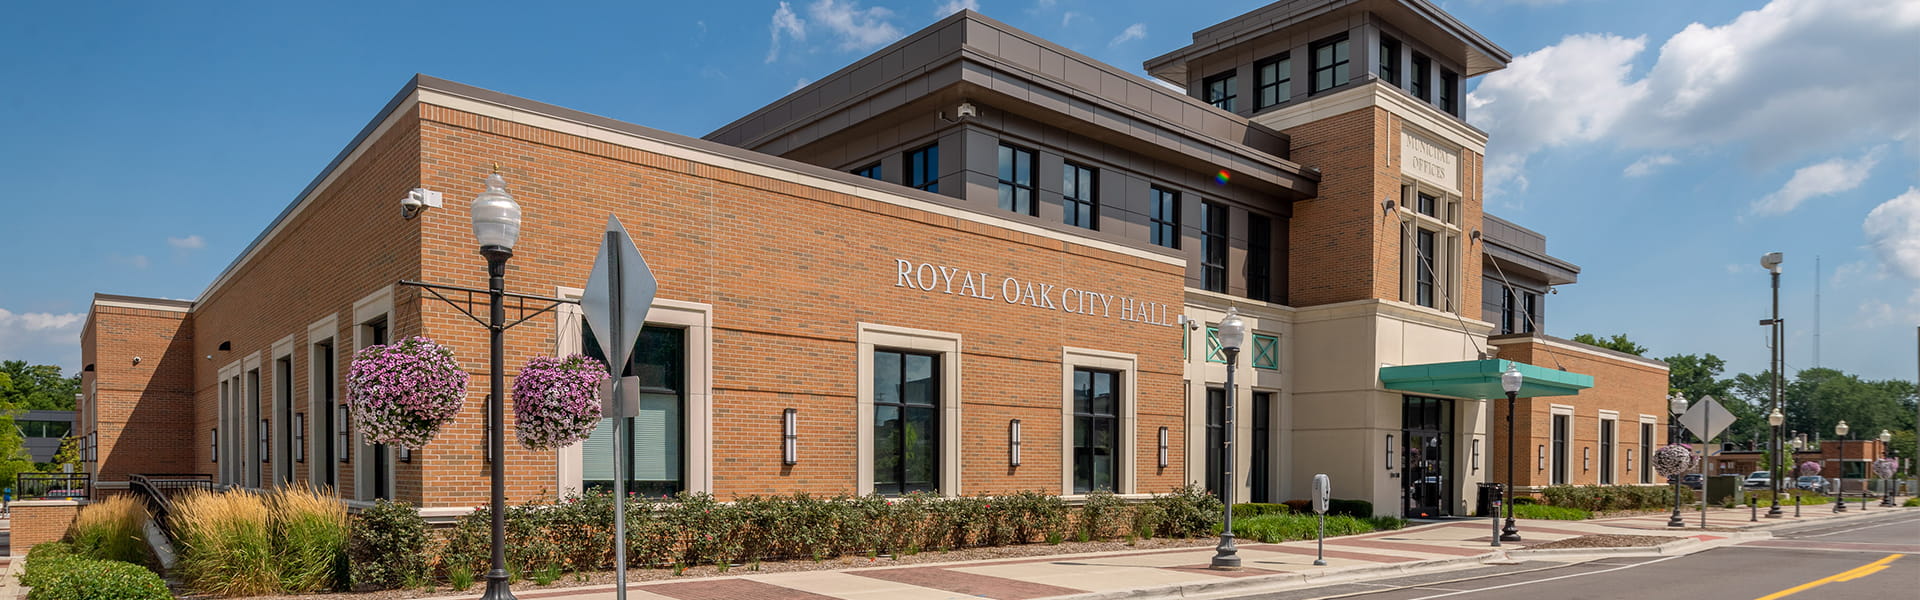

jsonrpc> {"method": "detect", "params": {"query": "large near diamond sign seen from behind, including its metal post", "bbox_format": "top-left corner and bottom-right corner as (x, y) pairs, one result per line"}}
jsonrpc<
(580, 215), (660, 600)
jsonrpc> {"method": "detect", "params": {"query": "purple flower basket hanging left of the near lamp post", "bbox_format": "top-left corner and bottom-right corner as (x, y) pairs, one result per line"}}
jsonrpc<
(348, 337), (467, 450)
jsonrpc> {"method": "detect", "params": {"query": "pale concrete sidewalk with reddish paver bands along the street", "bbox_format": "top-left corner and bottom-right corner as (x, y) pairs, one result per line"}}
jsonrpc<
(424, 506), (1887, 600)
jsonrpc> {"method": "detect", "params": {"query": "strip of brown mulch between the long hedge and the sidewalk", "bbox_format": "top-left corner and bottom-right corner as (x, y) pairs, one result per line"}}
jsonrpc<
(191, 538), (1217, 600)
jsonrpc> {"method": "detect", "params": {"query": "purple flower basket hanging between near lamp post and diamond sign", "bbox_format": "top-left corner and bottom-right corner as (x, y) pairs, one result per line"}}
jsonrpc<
(513, 354), (609, 450)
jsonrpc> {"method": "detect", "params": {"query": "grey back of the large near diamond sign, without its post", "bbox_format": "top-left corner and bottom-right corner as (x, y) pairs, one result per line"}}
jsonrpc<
(580, 215), (659, 417)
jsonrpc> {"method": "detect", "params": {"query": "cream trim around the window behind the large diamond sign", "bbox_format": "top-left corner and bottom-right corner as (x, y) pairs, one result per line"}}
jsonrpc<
(552, 287), (714, 496)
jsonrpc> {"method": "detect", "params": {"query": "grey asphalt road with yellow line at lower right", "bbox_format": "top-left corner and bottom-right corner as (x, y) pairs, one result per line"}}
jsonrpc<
(1238, 512), (1920, 600)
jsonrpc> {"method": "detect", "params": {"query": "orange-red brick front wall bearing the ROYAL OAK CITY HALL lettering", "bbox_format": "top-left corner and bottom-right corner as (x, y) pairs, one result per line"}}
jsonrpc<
(412, 106), (1183, 506)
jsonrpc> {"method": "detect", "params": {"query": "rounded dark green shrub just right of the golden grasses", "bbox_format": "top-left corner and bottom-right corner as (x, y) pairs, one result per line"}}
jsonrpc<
(348, 500), (432, 588)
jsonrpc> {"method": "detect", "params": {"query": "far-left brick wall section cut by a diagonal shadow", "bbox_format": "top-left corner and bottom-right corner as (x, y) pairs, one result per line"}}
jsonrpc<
(79, 304), (194, 481)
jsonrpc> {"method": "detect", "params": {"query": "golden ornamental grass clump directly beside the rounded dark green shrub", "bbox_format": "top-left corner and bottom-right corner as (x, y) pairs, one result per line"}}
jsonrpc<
(267, 487), (348, 594)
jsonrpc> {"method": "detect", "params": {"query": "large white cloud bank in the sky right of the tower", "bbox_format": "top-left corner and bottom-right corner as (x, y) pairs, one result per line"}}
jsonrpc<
(1467, 0), (1920, 194)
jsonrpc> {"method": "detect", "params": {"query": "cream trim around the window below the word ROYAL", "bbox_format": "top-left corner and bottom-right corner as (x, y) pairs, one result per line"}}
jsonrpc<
(854, 323), (967, 498)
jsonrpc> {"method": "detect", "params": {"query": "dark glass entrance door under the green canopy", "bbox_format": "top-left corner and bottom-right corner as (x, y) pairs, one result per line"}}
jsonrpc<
(1400, 396), (1453, 519)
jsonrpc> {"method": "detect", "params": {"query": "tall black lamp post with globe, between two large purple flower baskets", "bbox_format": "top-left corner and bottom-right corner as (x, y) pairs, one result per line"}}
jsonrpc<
(472, 165), (520, 600)
